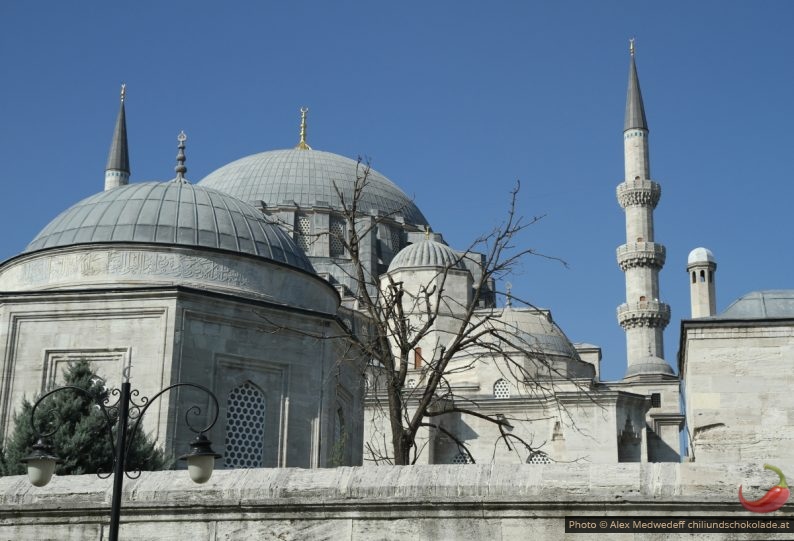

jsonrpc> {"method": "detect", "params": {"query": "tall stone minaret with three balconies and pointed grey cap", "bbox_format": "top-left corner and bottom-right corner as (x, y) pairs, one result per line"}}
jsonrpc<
(617, 40), (673, 378)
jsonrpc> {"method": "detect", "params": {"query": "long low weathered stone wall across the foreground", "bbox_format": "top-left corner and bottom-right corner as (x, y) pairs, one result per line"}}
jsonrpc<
(0, 463), (794, 541)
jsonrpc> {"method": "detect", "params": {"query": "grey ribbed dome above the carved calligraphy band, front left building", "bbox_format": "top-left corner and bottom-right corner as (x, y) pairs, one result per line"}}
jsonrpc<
(25, 182), (314, 272)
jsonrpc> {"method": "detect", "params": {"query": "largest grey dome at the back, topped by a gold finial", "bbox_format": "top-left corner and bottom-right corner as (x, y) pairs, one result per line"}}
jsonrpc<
(199, 149), (427, 225)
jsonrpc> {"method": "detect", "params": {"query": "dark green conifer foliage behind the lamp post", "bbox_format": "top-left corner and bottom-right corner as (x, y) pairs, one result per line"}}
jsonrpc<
(0, 361), (166, 475)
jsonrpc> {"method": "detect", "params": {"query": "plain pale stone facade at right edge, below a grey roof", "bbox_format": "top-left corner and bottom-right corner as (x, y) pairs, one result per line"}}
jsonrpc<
(679, 317), (794, 464)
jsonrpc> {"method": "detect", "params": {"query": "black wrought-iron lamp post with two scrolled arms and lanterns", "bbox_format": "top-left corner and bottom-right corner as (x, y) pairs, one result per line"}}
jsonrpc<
(22, 365), (221, 541)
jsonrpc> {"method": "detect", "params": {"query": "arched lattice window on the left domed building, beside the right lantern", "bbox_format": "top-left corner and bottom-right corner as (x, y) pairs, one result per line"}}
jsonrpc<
(224, 381), (265, 468)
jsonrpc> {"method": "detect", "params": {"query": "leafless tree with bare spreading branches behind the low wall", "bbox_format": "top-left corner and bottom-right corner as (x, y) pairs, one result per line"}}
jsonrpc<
(256, 160), (592, 465)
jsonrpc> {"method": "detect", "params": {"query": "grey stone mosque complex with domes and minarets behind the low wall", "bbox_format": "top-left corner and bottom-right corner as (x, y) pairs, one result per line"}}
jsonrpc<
(0, 44), (794, 468)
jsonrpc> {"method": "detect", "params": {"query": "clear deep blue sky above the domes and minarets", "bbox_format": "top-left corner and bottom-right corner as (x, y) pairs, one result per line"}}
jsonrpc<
(0, 0), (794, 378)
